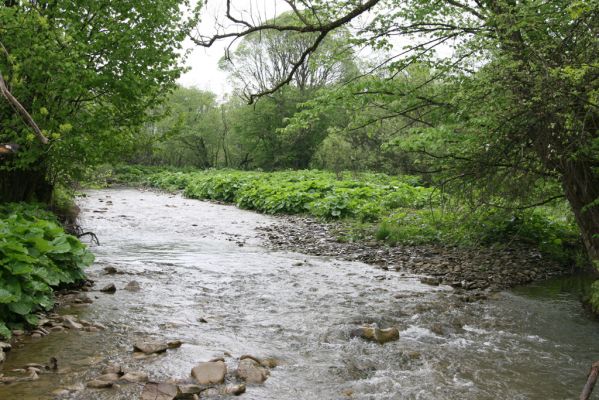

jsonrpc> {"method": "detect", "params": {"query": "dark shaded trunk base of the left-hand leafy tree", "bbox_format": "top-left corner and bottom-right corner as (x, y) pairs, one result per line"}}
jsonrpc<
(0, 169), (53, 203)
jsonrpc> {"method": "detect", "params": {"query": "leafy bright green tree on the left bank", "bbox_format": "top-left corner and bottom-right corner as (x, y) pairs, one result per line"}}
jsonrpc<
(0, 0), (195, 201)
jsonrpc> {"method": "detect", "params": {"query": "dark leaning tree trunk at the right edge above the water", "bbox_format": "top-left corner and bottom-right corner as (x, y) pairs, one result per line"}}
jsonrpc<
(563, 161), (599, 262)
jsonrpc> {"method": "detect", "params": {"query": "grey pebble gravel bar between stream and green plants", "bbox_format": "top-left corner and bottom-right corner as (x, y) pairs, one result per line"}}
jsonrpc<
(261, 216), (575, 292)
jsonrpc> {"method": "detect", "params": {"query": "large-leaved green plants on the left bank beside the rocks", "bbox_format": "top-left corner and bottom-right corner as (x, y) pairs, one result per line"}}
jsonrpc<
(0, 203), (94, 337)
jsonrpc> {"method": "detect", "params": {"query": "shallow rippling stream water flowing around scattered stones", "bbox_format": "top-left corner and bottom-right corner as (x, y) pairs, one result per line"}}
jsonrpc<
(0, 189), (599, 400)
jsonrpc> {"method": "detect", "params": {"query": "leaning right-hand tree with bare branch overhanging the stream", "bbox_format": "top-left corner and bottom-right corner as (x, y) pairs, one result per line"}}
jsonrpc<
(193, 0), (599, 261)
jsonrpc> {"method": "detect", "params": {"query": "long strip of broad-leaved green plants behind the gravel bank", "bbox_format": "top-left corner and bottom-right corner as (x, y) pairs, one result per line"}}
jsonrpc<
(96, 166), (582, 263)
